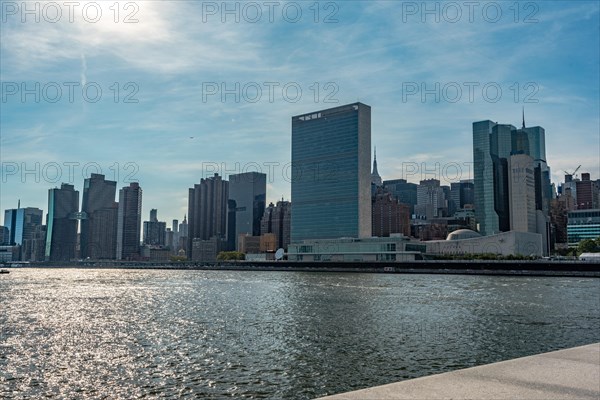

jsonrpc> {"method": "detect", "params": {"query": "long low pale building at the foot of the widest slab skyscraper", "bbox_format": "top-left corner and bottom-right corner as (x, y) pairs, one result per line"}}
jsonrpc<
(288, 235), (420, 262)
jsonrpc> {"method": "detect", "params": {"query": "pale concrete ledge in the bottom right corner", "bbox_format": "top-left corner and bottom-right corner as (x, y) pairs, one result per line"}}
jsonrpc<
(322, 343), (600, 400)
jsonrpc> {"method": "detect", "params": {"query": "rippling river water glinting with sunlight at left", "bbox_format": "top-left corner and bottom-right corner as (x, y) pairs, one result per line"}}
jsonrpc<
(0, 269), (600, 399)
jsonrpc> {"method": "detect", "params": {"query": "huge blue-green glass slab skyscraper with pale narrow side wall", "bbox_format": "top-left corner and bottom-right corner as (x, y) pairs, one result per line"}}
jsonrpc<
(291, 103), (371, 242)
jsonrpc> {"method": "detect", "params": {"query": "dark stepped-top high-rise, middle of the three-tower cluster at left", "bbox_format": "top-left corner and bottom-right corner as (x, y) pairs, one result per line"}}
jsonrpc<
(80, 174), (118, 259)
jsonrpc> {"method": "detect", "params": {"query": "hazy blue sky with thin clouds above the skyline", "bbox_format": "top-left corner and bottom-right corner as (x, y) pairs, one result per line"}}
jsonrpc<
(0, 0), (600, 227)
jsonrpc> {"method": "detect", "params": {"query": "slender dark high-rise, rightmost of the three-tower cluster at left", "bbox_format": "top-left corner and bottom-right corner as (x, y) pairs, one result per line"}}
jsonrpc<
(117, 182), (142, 260)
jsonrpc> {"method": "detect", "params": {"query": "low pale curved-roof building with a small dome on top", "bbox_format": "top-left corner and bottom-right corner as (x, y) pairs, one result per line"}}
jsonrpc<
(425, 229), (544, 257)
